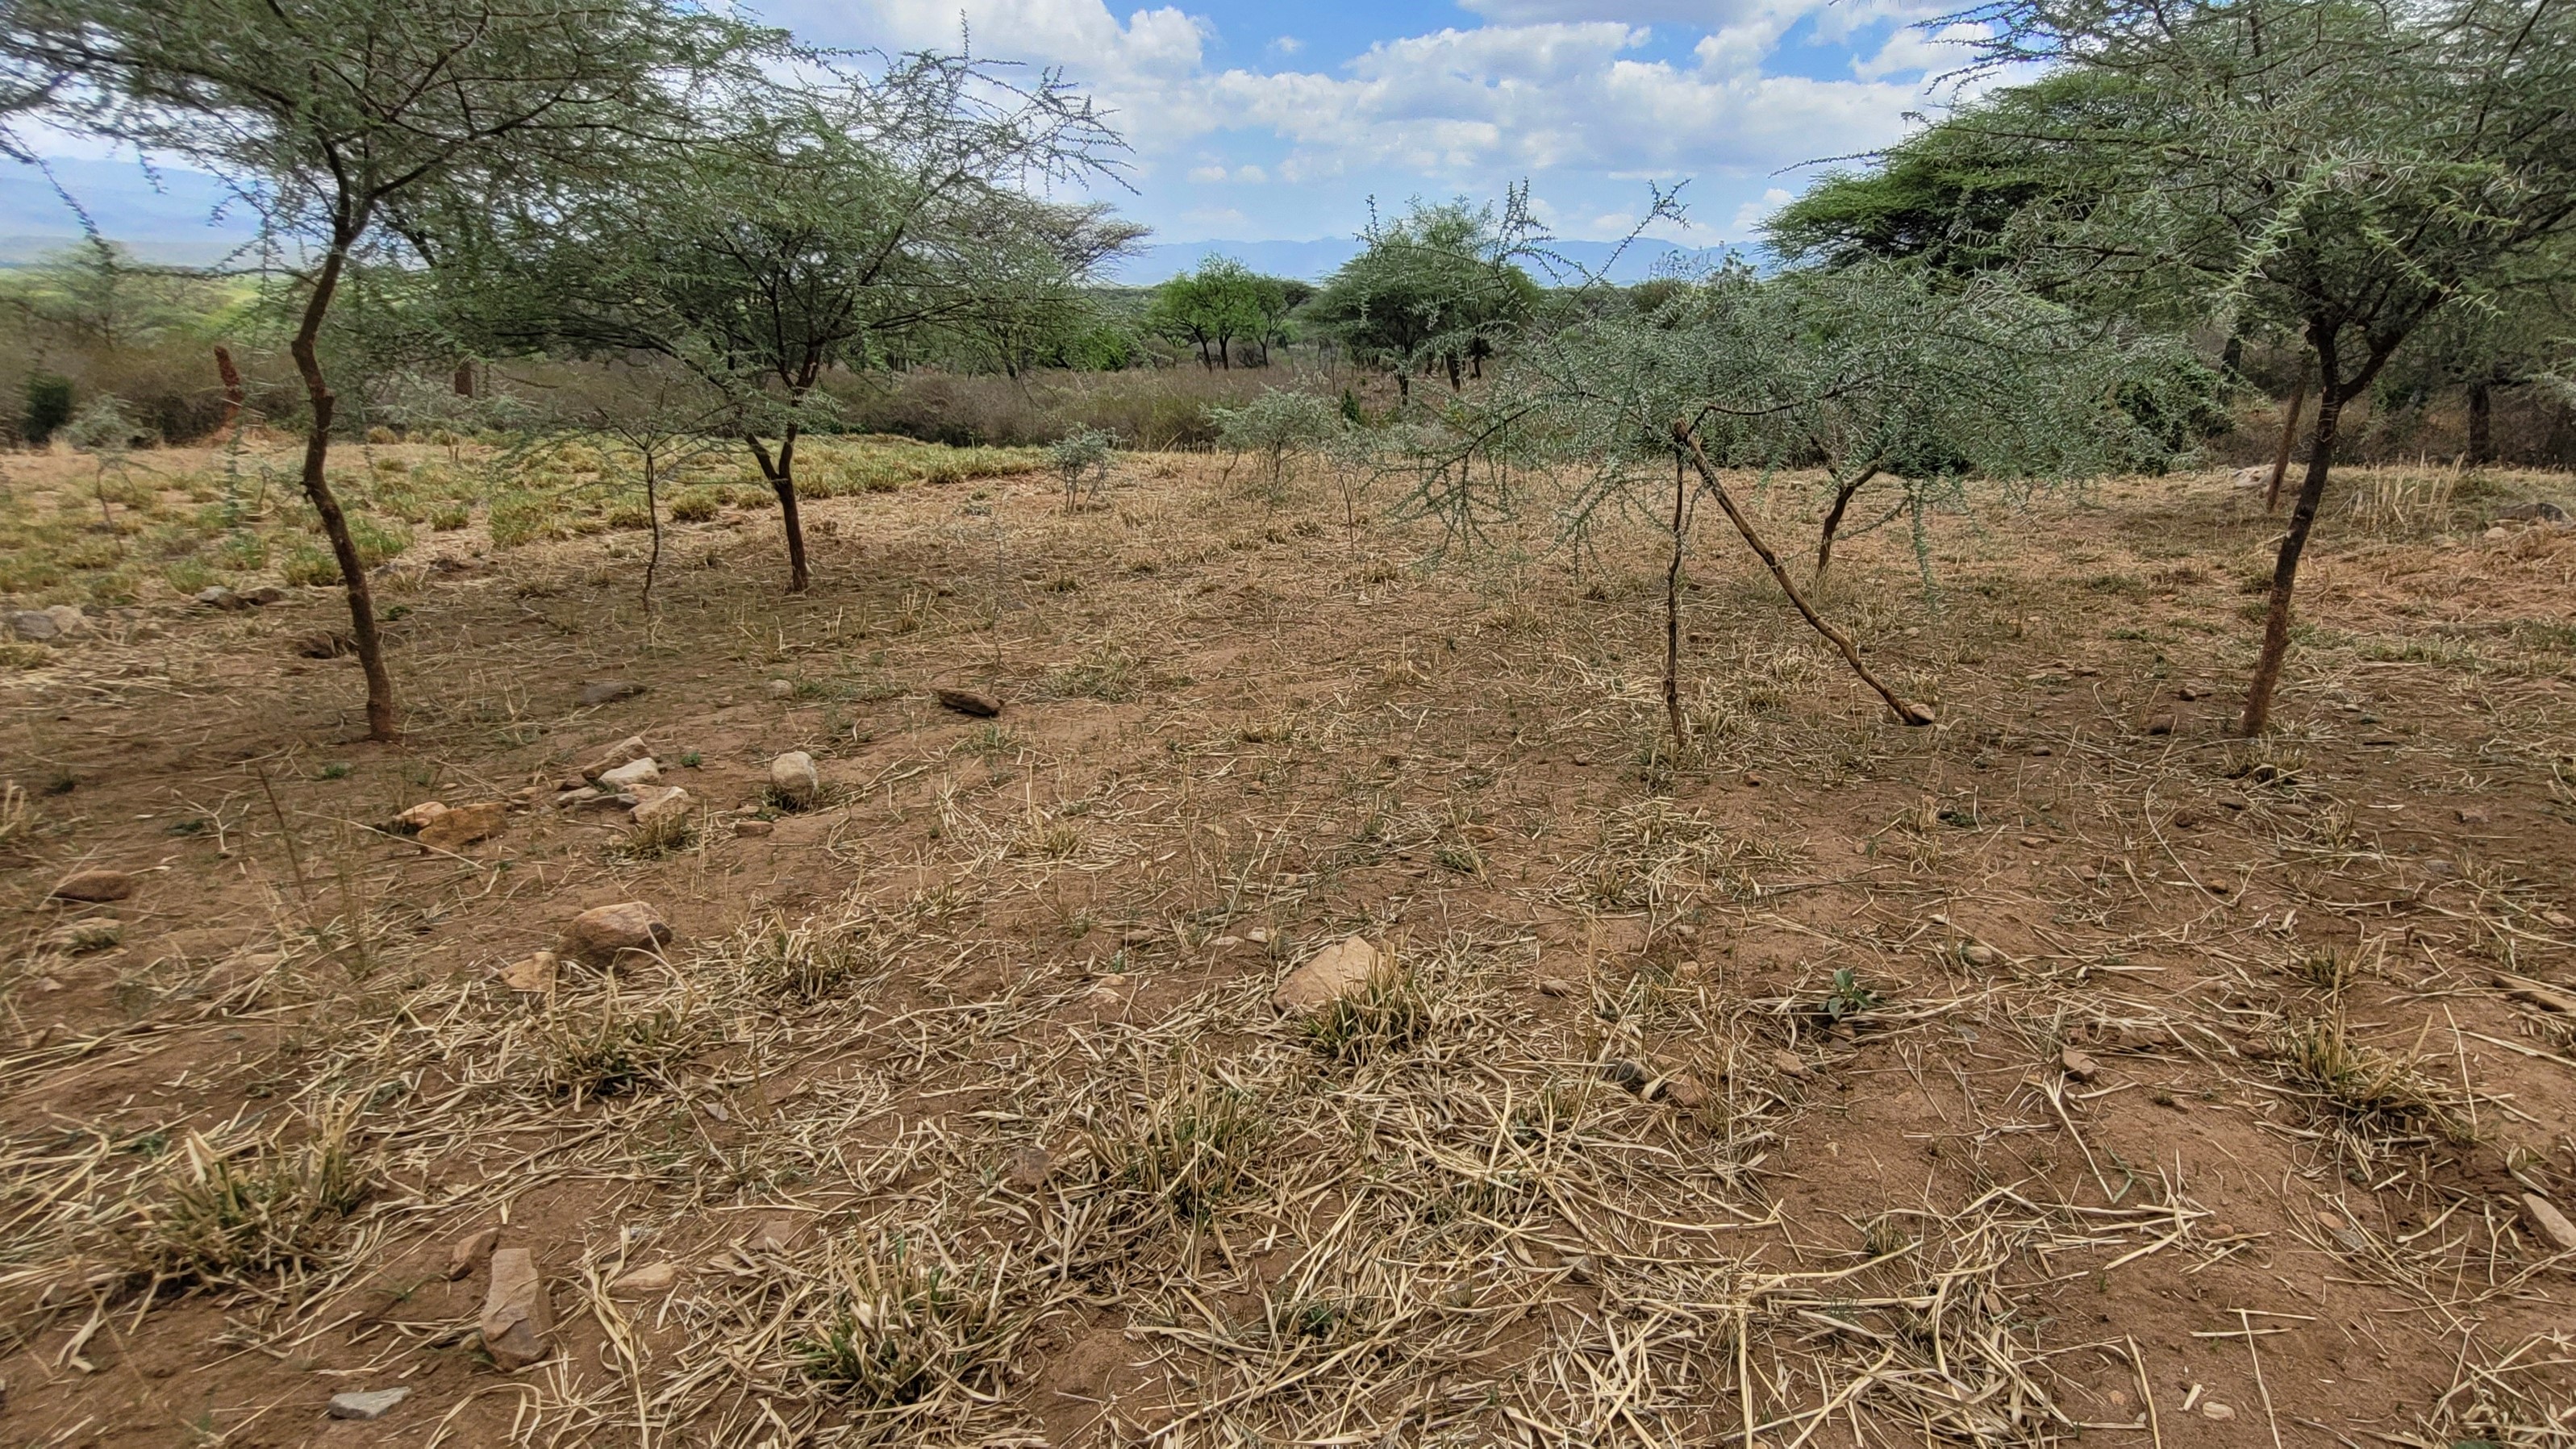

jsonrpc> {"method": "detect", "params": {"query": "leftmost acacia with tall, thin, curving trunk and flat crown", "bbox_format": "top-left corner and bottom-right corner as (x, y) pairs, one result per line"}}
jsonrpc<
(0, 0), (760, 739)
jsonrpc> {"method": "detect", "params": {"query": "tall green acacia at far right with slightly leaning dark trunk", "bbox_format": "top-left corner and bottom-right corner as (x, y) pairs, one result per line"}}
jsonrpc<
(1950, 0), (2576, 736)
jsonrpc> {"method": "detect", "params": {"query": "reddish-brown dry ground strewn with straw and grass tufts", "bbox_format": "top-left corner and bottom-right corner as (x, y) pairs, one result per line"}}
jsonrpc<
(0, 443), (2576, 1449)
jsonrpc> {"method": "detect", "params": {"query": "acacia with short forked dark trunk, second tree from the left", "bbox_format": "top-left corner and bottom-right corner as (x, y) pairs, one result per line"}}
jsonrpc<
(456, 54), (1133, 592)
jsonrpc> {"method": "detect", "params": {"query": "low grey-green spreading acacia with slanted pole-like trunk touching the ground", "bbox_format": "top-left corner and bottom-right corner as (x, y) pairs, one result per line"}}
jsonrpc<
(1424, 263), (2205, 743)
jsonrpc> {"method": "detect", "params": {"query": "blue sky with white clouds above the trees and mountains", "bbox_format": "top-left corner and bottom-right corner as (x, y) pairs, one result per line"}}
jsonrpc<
(0, 0), (1963, 266)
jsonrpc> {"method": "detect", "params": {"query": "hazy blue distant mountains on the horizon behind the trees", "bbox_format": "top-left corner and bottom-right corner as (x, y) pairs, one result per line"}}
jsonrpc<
(0, 160), (1736, 285)
